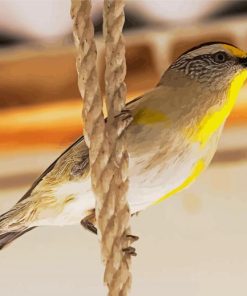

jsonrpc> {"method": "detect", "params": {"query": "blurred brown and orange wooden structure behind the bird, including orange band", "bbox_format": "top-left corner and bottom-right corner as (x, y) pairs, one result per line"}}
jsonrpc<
(0, 19), (247, 152)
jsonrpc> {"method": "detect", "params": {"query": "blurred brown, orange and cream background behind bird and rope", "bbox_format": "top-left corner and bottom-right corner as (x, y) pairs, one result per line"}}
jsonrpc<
(0, 0), (247, 296)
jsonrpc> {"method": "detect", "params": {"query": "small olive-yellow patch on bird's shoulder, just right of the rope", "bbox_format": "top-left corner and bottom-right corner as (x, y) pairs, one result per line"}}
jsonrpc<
(133, 108), (168, 125)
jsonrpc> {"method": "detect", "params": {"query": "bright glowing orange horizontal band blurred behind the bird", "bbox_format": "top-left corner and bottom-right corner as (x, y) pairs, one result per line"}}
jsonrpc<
(0, 93), (247, 151)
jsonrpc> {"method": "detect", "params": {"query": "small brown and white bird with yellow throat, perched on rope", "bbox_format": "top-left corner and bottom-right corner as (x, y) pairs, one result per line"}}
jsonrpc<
(0, 42), (247, 249)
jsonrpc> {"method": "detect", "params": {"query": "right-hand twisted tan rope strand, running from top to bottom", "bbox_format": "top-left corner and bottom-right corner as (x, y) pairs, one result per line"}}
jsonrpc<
(101, 0), (131, 295)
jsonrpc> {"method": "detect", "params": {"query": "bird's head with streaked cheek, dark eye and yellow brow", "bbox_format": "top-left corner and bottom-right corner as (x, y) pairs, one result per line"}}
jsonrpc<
(165, 42), (247, 91)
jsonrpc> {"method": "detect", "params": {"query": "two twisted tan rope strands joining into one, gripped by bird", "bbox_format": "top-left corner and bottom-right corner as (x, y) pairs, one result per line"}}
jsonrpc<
(71, 0), (133, 296)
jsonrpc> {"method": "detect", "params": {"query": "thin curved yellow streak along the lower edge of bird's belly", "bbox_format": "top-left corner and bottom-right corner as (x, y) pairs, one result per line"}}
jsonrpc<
(154, 159), (205, 204)
